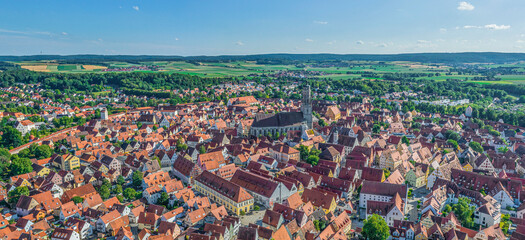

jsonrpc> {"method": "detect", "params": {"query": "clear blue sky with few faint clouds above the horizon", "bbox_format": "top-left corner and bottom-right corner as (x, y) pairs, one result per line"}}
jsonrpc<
(0, 0), (525, 56)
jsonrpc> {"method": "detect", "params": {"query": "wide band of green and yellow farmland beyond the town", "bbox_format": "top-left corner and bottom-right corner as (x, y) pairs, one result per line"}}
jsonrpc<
(10, 61), (525, 84)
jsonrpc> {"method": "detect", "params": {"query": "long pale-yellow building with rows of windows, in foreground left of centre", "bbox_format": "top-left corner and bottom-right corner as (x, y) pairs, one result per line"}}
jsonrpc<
(195, 171), (254, 215)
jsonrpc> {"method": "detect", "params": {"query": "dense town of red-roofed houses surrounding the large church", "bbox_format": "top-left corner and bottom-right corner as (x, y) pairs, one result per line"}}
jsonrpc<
(0, 81), (525, 240)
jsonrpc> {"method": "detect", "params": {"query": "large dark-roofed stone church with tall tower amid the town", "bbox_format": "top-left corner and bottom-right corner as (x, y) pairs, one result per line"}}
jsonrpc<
(250, 85), (313, 136)
